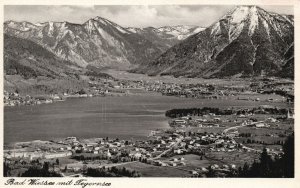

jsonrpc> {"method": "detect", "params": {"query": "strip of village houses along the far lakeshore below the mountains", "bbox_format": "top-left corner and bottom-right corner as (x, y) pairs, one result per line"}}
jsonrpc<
(4, 75), (294, 106)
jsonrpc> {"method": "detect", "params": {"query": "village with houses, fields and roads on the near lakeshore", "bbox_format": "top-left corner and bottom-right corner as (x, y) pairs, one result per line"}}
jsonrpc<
(4, 103), (293, 177)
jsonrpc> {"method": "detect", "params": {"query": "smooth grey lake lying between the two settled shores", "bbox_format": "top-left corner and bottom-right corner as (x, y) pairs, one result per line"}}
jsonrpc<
(4, 92), (288, 144)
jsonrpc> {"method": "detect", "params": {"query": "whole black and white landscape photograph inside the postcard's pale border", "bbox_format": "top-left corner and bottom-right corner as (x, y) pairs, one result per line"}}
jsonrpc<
(1, 1), (296, 182)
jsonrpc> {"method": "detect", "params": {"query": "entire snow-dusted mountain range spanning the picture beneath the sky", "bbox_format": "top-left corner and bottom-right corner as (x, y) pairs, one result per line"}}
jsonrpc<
(4, 6), (294, 93)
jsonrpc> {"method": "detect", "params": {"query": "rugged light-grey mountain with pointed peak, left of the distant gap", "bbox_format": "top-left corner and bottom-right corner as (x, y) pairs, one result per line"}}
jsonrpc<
(4, 17), (161, 68)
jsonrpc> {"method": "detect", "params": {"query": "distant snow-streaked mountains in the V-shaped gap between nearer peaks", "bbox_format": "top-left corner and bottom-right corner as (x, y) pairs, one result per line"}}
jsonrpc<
(127, 25), (205, 51)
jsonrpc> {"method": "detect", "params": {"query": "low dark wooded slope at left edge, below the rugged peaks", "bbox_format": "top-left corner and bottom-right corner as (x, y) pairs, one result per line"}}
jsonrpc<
(4, 34), (79, 79)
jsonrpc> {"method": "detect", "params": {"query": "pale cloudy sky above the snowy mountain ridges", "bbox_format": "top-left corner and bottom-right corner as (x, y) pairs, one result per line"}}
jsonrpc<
(4, 5), (293, 27)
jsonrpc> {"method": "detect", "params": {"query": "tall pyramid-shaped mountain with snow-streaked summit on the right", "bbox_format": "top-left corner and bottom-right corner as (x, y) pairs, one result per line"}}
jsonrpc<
(135, 6), (294, 77)
